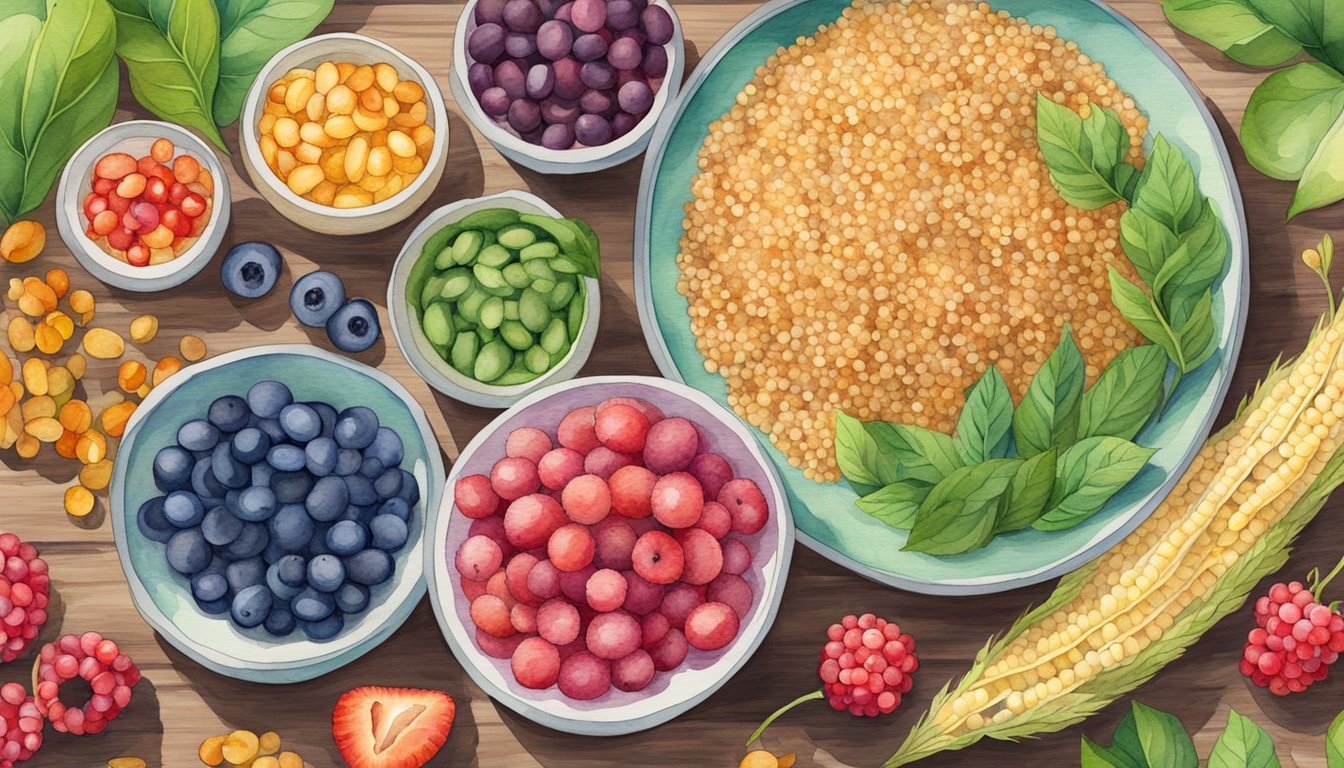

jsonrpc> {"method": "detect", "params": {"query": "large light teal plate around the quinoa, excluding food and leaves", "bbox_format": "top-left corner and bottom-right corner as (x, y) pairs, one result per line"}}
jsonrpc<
(634, 0), (1250, 594)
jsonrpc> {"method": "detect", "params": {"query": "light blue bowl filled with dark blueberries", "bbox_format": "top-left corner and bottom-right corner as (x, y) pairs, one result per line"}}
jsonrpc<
(110, 346), (445, 683)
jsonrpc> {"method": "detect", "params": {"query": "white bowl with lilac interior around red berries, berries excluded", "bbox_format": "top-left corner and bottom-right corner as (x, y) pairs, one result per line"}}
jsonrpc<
(425, 377), (793, 737)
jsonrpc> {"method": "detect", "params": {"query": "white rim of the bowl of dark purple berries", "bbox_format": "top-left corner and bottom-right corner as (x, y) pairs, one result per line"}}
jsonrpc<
(449, 0), (685, 165)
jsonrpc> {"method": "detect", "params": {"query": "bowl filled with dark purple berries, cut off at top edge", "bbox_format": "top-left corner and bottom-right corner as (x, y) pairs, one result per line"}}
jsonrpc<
(450, 0), (685, 174)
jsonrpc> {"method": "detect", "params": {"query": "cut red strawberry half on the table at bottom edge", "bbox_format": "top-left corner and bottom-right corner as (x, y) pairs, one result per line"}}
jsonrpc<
(332, 686), (457, 768)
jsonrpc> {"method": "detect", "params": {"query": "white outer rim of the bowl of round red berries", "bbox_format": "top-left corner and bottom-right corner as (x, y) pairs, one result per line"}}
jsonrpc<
(425, 375), (794, 736)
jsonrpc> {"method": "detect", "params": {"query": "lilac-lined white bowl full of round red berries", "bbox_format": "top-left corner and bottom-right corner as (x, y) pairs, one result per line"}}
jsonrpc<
(425, 377), (794, 736)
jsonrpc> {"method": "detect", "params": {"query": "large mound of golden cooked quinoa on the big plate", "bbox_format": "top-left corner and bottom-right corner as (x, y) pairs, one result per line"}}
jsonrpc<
(677, 0), (1148, 480)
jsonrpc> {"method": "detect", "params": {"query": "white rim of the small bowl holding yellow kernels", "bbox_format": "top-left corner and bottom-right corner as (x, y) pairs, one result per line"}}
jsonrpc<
(238, 32), (449, 219)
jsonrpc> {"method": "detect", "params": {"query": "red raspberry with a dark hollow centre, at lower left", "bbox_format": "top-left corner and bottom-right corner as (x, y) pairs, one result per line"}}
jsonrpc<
(33, 632), (140, 737)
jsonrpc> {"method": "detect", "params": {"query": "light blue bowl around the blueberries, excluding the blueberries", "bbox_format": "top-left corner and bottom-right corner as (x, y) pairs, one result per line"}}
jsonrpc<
(110, 346), (444, 683)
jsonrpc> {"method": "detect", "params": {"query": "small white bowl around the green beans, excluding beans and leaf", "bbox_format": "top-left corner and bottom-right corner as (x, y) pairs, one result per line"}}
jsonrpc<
(387, 190), (602, 408)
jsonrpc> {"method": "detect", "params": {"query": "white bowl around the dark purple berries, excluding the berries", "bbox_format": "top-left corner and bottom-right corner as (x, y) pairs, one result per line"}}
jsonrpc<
(449, 0), (685, 175)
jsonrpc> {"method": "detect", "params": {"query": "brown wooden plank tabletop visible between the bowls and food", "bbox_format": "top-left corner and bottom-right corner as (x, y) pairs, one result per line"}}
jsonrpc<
(0, 0), (1344, 768)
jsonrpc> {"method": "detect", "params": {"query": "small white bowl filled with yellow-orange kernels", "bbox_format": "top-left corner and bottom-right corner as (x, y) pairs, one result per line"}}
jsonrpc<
(242, 34), (448, 235)
